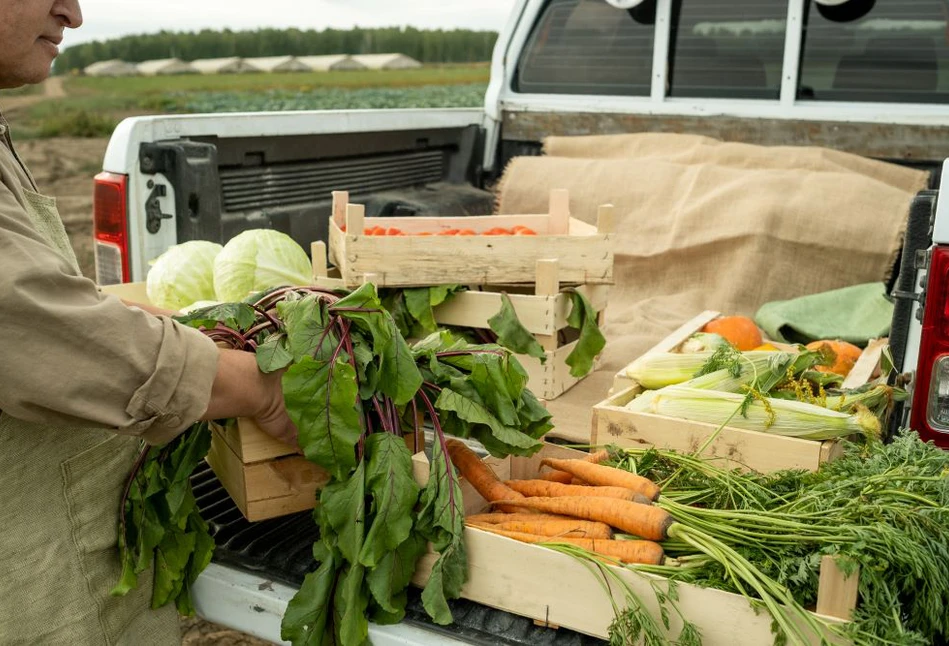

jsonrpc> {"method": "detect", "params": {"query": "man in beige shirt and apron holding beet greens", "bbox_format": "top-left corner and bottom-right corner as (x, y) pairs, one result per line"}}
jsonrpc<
(0, 0), (295, 646)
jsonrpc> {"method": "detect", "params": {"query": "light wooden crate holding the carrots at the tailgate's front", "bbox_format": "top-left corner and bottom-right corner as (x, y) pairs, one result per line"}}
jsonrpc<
(413, 445), (858, 646)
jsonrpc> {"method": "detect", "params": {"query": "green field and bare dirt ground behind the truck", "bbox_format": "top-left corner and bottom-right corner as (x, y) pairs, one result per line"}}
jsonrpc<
(0, 65), (488, 646)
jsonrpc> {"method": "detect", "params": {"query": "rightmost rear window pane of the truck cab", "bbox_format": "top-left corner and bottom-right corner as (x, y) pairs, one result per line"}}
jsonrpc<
(798, 0), (949, 103)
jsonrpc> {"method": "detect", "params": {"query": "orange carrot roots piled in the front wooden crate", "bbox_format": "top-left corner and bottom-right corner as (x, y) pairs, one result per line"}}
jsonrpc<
(448, 439), (674, 565)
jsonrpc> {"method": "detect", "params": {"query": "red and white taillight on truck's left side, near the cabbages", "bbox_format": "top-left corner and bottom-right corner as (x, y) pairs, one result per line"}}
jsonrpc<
(93, 172), (131, 285)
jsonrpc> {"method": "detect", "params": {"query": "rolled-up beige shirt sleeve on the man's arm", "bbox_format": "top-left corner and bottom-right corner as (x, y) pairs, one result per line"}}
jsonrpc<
(0, 185), (218, 444)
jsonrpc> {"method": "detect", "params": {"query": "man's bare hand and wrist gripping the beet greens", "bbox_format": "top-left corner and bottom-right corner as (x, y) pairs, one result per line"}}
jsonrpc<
(201, 349), (297, 446)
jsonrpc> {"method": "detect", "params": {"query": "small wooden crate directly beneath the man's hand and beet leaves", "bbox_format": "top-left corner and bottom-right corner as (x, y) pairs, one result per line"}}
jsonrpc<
(207, 420), (330, 522)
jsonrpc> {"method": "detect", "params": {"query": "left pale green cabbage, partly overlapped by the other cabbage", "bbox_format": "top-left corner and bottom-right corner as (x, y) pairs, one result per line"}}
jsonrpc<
(145, 240), (222, 310)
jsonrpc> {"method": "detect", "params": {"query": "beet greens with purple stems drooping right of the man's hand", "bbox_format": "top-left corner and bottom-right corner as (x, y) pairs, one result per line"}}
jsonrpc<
(116, 285), (551, 646)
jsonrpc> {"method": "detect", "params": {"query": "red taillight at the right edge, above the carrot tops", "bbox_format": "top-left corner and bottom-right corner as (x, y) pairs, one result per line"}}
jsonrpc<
(910, 247), (949, 448)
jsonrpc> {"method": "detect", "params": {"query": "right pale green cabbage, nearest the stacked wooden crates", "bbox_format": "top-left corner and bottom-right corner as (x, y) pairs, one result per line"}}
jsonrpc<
(212, 229), (313, 302)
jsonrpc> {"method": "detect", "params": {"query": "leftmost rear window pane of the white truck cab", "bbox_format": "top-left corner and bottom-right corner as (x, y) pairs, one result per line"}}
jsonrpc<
(514, 0), (655, 96)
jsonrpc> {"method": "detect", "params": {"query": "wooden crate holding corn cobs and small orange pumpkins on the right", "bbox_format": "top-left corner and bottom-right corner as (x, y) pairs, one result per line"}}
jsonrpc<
(592, 311), (887, 472)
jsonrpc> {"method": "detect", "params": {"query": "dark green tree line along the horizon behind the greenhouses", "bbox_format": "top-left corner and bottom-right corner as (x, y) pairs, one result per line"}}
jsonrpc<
(56, 27), (498, 73)
